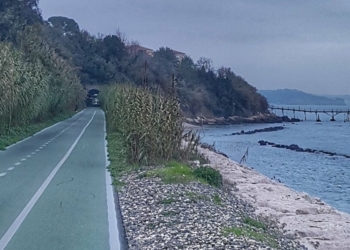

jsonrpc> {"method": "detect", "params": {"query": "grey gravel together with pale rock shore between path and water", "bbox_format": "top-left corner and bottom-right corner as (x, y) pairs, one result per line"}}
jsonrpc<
(118, 125), (350, 250)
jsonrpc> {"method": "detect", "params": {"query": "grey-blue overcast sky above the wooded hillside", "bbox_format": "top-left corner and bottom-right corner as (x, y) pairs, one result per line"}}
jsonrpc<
(40, 0), (350, 94)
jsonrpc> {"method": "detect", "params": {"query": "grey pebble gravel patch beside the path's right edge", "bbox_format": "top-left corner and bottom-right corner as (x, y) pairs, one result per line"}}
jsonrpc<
(118, 172), (307, 250)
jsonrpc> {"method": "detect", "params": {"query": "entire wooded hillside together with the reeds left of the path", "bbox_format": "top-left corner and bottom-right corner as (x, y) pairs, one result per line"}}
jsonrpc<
(0, 0), (268, 139)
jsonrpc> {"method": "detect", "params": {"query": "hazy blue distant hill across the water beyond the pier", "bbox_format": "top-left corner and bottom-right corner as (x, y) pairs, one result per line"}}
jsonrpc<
(258, 89), (346, 106)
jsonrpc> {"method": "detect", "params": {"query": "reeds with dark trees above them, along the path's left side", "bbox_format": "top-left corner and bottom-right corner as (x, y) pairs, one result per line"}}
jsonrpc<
(0, 0), (85, 135)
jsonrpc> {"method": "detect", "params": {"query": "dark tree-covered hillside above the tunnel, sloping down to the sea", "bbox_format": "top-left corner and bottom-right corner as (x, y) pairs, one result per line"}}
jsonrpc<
(45, 17), (268, 117)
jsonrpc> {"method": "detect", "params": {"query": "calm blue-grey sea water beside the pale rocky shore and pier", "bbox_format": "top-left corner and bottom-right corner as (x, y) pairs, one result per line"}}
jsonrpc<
(202, 106), (350, 213)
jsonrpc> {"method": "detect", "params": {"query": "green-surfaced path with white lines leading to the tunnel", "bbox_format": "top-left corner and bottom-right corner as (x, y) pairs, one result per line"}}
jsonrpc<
(0, 108), (122, 250)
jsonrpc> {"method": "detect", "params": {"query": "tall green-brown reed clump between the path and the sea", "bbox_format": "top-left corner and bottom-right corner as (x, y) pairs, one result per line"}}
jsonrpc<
(100, 84), (184, 165)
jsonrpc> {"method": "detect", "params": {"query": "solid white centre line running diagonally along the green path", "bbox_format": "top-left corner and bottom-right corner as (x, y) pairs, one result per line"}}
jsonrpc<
(0, 111), (96, 250)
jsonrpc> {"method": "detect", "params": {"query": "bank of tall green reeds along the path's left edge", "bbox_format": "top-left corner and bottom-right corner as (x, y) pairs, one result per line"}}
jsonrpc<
(0, 42), (84, 135)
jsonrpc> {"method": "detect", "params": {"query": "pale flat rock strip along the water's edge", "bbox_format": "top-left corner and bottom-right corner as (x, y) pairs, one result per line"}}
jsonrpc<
(199, 148), (350, 250)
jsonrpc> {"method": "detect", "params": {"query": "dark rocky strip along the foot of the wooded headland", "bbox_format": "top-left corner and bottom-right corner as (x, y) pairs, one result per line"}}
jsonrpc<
(185, 114), (301, 126)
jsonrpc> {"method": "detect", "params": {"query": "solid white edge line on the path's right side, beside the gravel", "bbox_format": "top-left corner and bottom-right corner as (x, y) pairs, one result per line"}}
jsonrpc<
(104, 111), (121, 250)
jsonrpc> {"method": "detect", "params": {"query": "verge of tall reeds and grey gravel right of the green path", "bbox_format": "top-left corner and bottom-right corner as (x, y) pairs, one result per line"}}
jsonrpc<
(101, 85), (305, 250)
